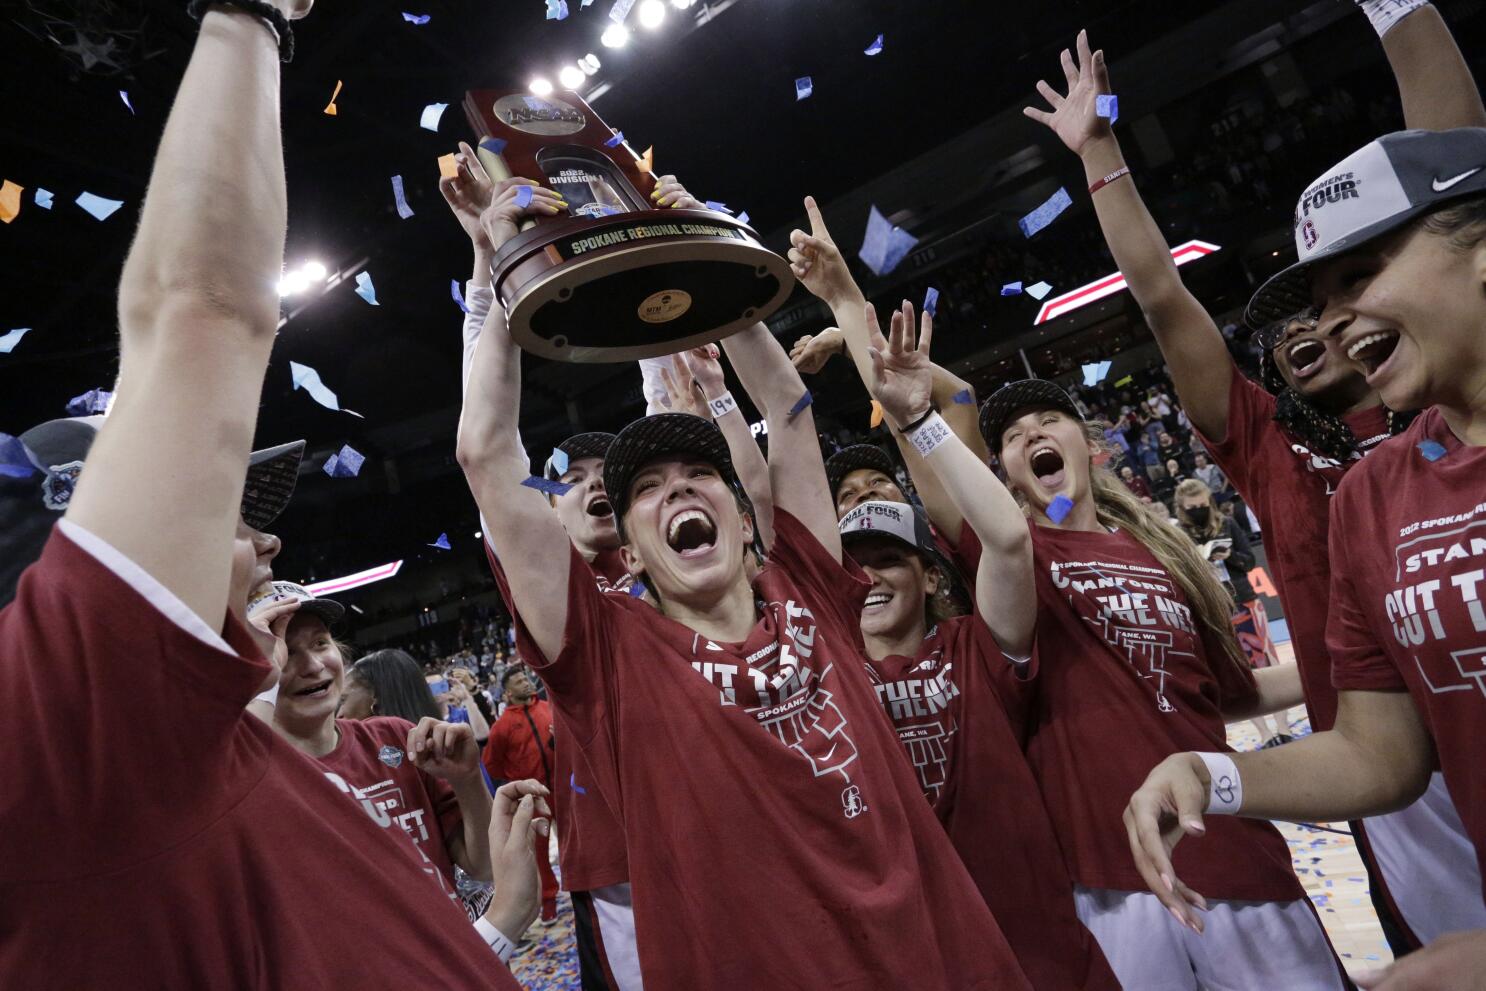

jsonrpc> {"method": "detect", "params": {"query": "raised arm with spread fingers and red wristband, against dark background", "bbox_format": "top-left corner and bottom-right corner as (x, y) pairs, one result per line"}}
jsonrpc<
(1022, 31), (1235, 443)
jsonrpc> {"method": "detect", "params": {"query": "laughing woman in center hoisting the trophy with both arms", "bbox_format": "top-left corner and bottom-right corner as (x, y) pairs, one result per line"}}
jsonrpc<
(459, 271), (1030, 991)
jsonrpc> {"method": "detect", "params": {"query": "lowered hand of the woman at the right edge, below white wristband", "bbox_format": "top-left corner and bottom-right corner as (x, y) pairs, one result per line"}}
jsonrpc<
(1125, 753), (1208, 933)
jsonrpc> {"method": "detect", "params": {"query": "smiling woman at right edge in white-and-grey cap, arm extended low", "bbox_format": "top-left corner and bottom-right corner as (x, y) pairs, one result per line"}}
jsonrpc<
(1126, 128), (1486, 988)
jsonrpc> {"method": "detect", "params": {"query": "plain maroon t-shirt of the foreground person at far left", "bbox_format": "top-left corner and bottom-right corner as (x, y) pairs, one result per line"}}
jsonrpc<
(0, 524), (517, 990)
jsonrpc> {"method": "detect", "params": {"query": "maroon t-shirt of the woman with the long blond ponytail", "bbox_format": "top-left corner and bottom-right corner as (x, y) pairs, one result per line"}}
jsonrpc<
(958, 520), (1305, 902)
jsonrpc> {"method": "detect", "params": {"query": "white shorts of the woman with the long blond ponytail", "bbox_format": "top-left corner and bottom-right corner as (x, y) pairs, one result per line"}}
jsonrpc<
(1073, 884), (1348, 991)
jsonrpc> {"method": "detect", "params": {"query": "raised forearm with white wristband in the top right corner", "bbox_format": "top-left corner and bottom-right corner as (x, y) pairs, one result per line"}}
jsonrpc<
(1358, 0), (1486, 131)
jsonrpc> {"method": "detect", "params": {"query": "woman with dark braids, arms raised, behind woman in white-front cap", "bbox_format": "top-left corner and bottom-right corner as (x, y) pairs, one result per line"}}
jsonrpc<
(1027, 25), (1486, 951)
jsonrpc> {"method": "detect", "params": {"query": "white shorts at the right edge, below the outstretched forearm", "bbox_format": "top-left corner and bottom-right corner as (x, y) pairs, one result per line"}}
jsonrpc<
(1363, 773), (1486, 943)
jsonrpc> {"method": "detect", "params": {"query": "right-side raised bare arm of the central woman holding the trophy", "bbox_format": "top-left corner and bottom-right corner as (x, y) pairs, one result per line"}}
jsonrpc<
(722, 324), (841, 559)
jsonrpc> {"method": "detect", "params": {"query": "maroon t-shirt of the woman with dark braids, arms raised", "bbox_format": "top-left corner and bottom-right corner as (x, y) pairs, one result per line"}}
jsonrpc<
(1202, 370), (1388, 731)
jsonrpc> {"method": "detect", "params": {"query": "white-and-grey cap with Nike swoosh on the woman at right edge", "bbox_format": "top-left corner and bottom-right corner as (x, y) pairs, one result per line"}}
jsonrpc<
(1244, 128), (1486, 328)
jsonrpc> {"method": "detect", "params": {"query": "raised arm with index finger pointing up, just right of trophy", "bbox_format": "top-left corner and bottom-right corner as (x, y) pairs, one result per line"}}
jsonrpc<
(789, 196), (988, 542)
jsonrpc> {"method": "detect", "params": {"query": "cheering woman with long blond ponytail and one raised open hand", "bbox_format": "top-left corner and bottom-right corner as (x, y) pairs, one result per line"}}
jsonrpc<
(866, 303), (1345, 990)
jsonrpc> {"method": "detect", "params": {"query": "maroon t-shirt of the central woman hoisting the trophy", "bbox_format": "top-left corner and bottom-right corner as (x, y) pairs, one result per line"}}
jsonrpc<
(493, 510), (1031, 991)
